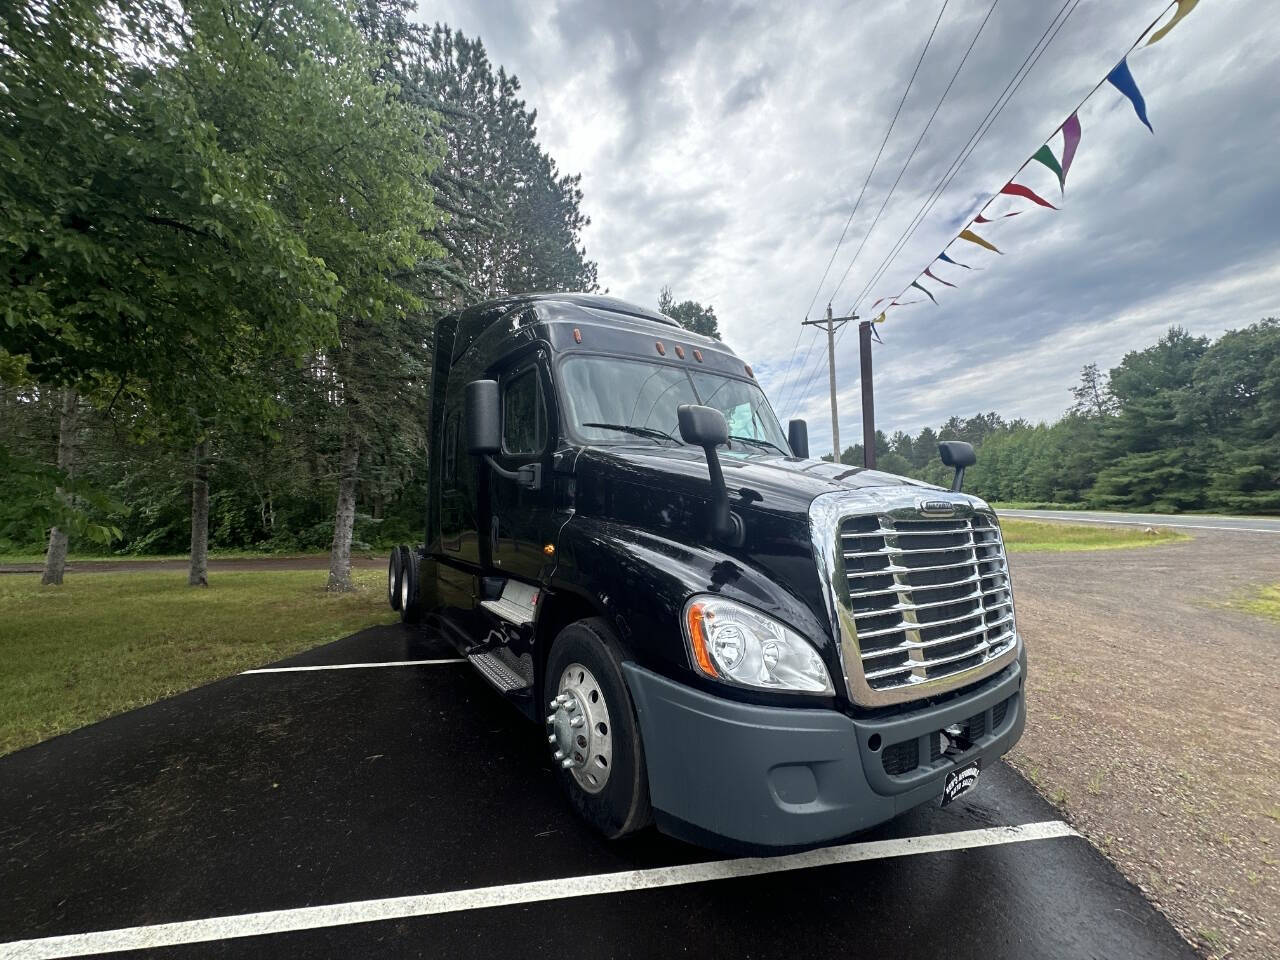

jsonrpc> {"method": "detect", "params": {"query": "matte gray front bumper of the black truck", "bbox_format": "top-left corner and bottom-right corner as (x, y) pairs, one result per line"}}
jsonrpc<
(622, 650), (1027, 847)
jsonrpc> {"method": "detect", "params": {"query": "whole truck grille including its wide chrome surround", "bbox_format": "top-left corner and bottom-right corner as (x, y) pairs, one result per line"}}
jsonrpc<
(809, 485), (1021, 707)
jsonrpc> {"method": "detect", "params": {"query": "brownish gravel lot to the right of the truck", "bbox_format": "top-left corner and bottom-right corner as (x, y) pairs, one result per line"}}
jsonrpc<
(1010, 530), (1280, 959)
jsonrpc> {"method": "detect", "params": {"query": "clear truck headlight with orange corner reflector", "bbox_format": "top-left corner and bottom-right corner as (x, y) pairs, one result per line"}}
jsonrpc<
(685, 595), (836, 696)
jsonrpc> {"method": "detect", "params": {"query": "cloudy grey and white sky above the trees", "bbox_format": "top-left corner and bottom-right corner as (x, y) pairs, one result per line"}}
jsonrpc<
(420, 0), (1280, 452)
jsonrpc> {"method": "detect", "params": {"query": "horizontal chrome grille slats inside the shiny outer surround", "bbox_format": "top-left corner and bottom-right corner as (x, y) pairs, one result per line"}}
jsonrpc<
(840, 511), (1015, 699)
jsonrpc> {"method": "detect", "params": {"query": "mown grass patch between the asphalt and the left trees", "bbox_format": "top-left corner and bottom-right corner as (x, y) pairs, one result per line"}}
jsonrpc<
(0, 570), (396, 754)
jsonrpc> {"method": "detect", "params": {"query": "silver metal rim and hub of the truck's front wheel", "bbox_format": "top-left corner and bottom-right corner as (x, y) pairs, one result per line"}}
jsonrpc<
(547, 663), (613, 794)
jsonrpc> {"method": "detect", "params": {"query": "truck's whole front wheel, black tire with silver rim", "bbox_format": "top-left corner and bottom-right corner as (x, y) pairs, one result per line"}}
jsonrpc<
(545, 618), (650, 840)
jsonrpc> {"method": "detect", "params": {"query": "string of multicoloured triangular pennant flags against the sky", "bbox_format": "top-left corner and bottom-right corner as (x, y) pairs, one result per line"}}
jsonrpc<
(870, 0), (1199, 323)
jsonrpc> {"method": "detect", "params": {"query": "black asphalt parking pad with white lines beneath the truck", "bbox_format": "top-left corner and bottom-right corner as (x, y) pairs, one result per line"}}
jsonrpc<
(0, 626), (1193, 960)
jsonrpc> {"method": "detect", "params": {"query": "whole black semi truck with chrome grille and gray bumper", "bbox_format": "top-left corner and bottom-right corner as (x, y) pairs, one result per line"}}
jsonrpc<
(388, 294), (1027, 850)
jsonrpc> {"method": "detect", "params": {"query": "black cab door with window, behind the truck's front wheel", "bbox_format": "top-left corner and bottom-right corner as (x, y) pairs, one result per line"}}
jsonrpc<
(488, 351), (556, 584)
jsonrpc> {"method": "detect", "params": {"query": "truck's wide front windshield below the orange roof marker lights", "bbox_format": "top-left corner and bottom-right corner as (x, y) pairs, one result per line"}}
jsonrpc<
(561, 357), (791, 456)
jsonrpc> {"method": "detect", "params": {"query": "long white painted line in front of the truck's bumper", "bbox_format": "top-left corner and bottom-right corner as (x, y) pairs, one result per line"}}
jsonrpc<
(0, 820), (1079, 960)
